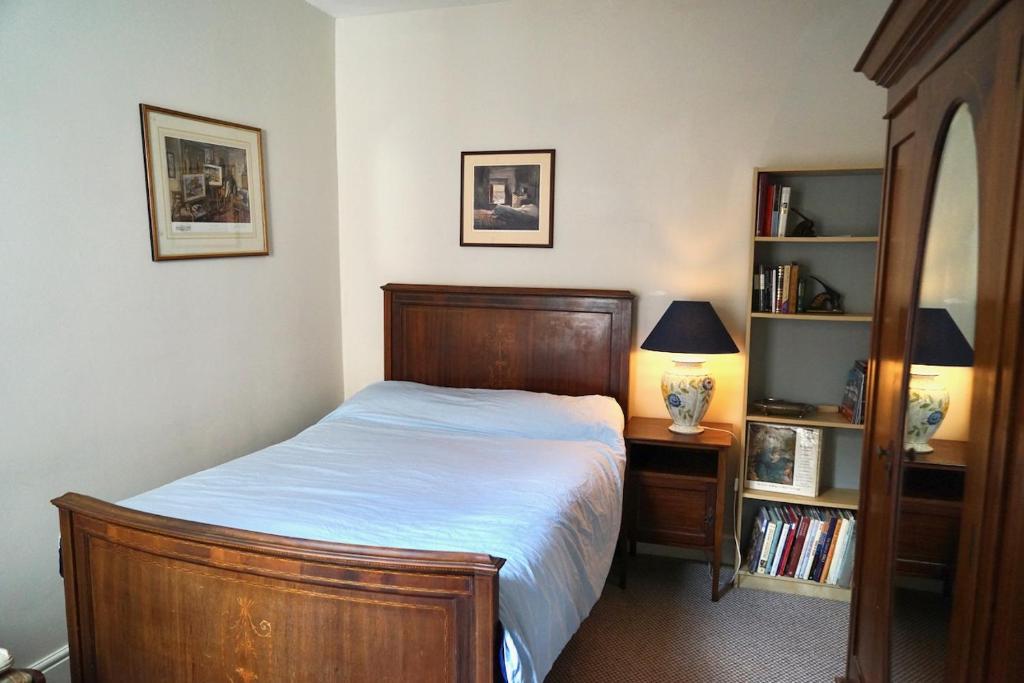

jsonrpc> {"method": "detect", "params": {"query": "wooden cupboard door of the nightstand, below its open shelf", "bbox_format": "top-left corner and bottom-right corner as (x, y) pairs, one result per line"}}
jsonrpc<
(630, 471), (717, 546)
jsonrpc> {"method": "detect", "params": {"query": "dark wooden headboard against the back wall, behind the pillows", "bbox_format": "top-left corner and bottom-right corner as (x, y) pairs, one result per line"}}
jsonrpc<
(382, 285), (633, 413)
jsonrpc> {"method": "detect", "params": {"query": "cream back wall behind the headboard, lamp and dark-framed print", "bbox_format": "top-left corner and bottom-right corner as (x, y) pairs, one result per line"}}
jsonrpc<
(336, 0), (888, 423)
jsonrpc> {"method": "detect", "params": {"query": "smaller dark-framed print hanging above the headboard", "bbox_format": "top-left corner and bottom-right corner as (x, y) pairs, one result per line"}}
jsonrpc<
(459, 150), (555, 247)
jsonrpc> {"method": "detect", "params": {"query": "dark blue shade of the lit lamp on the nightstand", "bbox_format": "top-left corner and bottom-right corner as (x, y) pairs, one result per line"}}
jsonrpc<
(640, 301), (739, 354)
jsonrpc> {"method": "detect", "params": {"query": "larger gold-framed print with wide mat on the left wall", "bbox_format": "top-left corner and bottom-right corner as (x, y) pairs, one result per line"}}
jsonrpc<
(139, 104), (270, 261)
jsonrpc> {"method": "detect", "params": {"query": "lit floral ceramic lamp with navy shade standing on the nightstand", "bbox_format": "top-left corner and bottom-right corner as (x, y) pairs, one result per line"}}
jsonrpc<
(640, 301), (739, 434)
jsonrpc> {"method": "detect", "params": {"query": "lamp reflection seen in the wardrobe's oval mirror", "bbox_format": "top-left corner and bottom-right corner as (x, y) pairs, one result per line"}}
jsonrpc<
(903, 308), (974, 453)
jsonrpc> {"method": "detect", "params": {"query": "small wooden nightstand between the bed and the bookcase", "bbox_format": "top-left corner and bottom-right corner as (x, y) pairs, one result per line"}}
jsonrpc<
(624, 418), (732, 602)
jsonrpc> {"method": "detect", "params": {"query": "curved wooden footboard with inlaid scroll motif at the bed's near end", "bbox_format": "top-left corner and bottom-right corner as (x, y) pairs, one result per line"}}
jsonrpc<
(53, 494), (504, 683)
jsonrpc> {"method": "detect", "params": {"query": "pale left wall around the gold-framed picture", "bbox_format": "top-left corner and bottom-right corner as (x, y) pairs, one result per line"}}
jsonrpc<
(0, 0), (341, 665)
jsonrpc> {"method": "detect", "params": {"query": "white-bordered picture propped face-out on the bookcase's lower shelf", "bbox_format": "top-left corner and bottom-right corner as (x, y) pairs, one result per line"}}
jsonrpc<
(744, 422), (821, 498)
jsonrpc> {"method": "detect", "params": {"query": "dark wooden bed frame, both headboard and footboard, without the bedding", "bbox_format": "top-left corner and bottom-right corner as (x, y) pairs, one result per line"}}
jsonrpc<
(53, 285), (633, 683)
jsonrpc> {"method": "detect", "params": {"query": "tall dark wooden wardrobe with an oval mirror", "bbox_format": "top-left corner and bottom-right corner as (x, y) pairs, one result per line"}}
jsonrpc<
(846, 0), (1024, 683)
